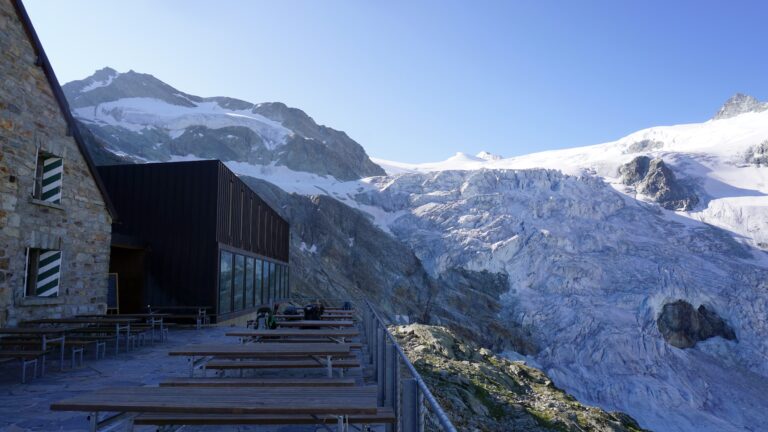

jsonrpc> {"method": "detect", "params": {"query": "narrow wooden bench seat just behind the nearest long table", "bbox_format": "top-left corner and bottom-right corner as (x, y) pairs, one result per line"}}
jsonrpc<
(160, 378), (355, 387)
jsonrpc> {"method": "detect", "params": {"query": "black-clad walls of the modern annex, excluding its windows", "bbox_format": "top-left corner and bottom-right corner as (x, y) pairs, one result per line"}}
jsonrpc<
(99, 160), (290, 318)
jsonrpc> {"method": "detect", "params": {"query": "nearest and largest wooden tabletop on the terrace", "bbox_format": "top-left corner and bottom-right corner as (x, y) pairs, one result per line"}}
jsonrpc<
(51, 386), (377, 415)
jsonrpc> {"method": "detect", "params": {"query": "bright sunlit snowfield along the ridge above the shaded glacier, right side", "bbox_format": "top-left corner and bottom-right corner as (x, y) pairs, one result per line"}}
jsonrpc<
(374, 108), (768, 250)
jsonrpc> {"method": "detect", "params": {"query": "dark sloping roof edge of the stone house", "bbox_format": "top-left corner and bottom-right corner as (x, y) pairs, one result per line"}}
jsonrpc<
(13, 0), (117, 221)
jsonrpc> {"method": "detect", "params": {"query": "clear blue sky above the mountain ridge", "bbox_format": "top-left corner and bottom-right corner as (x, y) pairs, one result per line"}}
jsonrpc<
(25, 0), (768, 162)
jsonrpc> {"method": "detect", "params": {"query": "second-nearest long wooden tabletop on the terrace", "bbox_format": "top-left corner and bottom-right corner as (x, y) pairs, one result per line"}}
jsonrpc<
(168, 342), (351, 358)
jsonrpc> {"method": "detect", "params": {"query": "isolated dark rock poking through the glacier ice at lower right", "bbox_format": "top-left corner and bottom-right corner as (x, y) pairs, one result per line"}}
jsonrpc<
(656, 300), (736, 348)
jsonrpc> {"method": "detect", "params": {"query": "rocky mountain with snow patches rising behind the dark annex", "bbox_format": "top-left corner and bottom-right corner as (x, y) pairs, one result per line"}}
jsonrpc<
(63, 68), (384, 180)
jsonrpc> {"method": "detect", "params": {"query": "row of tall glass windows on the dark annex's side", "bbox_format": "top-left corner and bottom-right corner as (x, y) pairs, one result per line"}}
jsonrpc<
(219, 249), (290, 314)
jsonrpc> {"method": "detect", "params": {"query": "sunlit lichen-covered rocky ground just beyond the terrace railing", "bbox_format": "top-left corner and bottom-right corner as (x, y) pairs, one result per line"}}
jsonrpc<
(390, 324), (643, 432)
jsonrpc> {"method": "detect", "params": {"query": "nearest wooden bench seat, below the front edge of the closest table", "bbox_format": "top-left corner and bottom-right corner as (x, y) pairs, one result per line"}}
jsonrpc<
(133, 408), (397, 426)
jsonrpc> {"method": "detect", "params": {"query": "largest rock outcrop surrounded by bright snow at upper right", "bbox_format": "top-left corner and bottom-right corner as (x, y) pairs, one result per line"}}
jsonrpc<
(619, 156), (699, 211)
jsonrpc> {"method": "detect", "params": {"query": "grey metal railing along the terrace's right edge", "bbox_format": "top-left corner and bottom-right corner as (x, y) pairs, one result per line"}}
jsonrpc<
(362, 300), (456, 432)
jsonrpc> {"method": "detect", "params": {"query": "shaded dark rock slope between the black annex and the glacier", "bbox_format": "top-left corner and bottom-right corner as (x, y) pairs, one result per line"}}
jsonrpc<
(242, 177), (520, 351)
